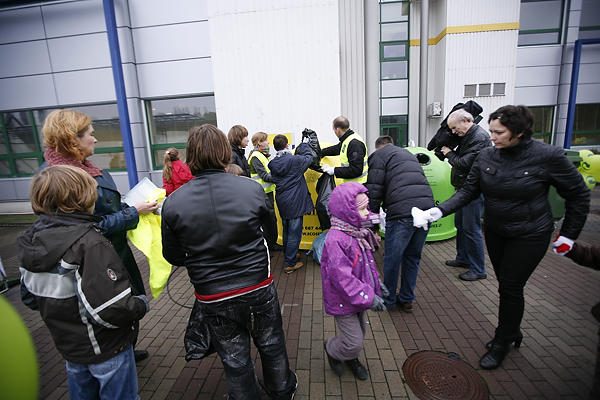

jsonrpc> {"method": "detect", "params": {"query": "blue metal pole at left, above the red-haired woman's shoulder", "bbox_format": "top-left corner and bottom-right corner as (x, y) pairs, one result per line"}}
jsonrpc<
(102, 0), (138, 187)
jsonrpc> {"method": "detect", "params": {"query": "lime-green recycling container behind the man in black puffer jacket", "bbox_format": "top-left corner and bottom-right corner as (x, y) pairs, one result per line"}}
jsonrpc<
(406, 147), (456, 242)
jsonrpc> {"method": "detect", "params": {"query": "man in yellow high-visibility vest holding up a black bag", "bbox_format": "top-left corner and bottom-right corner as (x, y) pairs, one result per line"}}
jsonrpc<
(321, 115), (367, 184)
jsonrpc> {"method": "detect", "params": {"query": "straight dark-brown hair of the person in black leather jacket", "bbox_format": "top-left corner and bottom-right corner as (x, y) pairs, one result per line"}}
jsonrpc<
(186, 124), (231, 175)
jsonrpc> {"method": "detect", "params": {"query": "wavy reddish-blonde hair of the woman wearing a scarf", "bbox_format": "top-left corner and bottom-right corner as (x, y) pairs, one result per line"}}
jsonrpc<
(42, 109), (92, 161)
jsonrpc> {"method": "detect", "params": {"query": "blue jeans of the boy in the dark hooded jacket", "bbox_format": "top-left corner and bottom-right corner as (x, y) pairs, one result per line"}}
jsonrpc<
(66, 346), (139, 400)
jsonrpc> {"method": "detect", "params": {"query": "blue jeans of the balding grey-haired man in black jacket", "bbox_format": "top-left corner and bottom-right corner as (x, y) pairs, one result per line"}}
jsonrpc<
(454, 196), (485, 275)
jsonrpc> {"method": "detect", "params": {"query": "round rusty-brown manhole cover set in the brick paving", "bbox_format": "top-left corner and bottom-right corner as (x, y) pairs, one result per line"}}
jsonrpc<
(402, 351), (489, 400)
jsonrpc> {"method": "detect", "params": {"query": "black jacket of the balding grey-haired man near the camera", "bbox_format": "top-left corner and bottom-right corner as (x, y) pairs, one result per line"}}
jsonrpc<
(446, 124), (492, 188)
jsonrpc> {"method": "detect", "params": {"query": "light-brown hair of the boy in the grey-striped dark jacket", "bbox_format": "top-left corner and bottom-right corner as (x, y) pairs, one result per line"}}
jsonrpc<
(30, 165), (98, 214)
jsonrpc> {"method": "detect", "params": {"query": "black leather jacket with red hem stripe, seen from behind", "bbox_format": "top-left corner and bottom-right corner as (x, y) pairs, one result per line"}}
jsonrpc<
(162, 170), (270, 296)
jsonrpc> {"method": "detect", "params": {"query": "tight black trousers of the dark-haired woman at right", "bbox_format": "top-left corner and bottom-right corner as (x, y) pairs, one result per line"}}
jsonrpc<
(485, 229), (552, 341)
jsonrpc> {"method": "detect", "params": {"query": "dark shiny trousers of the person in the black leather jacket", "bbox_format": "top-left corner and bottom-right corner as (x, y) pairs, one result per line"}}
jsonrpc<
(200, 284), (297, 400)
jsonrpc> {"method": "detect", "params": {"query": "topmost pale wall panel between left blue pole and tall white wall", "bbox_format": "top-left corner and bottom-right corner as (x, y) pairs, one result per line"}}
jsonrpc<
(129, 0), (208, 27)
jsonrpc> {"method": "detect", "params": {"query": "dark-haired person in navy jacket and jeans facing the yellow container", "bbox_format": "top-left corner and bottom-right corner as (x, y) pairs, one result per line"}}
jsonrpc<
(269, 135), (314, 274)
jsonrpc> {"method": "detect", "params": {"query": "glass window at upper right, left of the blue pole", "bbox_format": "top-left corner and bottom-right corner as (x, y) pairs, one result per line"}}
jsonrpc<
(519, 0), (563, 46)
